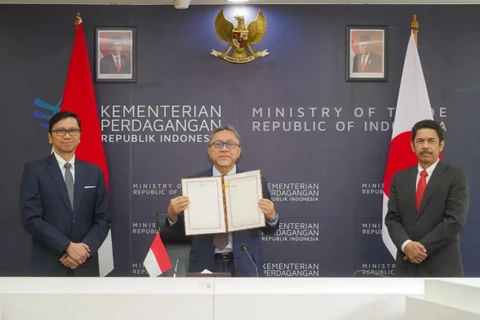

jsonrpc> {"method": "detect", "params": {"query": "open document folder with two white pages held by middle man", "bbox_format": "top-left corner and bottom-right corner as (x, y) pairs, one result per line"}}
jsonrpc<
(182, 170), (265, 235)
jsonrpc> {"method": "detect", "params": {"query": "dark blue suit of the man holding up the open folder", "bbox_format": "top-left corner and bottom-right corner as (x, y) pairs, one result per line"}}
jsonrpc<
(165, 167), (280, 277)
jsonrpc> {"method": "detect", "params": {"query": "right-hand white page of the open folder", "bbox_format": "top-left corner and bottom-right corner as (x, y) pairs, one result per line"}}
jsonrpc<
(224, 170), (265, 231)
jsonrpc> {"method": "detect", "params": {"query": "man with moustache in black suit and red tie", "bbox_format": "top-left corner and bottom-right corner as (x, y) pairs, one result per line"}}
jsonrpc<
(385, 120), (469, 277)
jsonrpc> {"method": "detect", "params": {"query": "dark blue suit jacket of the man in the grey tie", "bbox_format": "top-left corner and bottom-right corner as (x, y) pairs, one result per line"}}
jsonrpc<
(20, 154), (110, 276)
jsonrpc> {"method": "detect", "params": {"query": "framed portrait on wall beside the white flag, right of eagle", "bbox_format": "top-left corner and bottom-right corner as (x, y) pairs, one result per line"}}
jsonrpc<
(346, 26), (388, 81)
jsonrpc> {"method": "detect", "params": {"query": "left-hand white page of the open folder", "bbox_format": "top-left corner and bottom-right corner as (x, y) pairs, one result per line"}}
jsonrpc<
(182, 177), (226, 235)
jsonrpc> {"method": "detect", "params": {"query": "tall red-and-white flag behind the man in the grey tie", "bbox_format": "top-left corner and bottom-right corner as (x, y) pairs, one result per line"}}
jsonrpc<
(60, 18), (114, 277)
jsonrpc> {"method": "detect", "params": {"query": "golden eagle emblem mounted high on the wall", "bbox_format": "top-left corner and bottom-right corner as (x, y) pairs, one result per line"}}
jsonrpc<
(211, 9), (269, 63)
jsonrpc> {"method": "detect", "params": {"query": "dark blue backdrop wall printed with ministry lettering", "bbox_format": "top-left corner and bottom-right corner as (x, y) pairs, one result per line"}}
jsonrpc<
(0, 5), (480, 277)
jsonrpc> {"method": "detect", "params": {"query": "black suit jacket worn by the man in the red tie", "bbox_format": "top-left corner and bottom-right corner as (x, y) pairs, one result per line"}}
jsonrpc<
(385, 162), (469, 277)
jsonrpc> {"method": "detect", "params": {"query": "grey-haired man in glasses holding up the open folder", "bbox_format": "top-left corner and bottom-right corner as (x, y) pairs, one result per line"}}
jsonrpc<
(166, 126), (279, 277)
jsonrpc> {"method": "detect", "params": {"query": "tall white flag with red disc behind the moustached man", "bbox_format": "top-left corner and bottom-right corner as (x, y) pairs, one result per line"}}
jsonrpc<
(382, 32), (433, 259)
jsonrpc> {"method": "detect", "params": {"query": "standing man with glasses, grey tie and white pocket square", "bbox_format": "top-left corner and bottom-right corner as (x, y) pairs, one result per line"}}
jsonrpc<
(20, 112), (110, 277)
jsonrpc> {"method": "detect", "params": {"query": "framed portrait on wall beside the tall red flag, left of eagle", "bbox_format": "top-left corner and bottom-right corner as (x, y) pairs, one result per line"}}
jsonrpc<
(95, 27), (137, 82)
